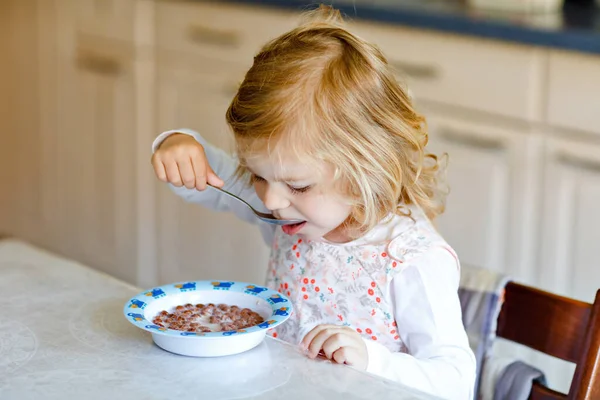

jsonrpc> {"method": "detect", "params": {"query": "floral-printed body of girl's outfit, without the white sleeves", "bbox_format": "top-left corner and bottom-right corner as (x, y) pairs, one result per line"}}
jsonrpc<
(267, 206), (449, 352)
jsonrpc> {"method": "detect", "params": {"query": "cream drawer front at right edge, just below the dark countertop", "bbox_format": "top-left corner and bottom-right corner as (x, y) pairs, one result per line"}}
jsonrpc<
(546, 52), (600, 135)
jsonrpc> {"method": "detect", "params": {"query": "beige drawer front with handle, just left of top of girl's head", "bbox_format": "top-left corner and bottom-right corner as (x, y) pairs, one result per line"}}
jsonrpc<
(156, 2), (297, 64)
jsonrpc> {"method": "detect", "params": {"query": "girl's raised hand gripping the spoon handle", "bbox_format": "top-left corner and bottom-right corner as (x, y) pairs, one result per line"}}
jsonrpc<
(152, 133), (223, 190)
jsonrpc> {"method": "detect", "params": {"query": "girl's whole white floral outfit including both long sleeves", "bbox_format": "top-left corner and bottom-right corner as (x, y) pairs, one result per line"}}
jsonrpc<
(153, 129), (475, 400)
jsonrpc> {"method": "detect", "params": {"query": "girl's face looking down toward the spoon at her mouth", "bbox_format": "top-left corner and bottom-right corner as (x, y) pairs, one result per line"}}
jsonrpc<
(247, 152), (351, 242)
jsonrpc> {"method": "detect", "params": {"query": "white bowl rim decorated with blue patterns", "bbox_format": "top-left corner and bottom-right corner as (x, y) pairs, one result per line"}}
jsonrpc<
(123, 281), (293, 338)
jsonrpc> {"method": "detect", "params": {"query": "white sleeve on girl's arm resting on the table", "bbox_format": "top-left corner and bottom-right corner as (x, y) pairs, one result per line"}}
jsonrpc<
(365, 248), (476, 400)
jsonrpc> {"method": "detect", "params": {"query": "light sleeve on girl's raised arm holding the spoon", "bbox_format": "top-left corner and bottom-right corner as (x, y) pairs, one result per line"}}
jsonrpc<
(152, 128), (275, 245)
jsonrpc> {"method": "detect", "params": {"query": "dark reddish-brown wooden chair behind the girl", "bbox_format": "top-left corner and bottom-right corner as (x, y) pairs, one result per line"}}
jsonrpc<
(497, 282), (600, 400)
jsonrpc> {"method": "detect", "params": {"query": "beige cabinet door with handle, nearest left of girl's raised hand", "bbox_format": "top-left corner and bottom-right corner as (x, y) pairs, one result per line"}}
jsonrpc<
(42, 36), (137, 282)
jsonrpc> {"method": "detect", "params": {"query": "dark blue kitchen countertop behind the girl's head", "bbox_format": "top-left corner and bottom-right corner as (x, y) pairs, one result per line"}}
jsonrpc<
(222, 0), (600, 54)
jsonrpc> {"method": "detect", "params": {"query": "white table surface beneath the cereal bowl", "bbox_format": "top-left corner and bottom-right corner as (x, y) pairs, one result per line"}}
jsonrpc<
(0, 240), (440, 400)
